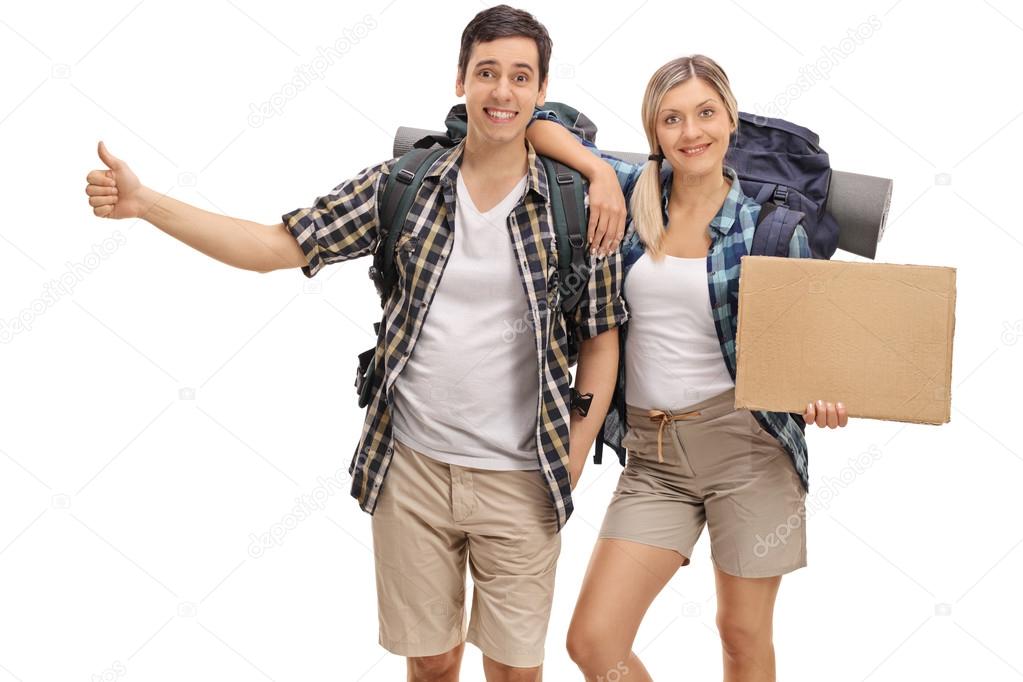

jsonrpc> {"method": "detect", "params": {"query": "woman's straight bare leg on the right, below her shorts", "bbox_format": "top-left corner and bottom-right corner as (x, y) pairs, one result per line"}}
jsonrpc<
(714, 566), (782, 682)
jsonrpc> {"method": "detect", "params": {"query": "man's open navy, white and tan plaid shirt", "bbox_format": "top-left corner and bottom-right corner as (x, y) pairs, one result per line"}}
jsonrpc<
(281, 141), (628, 531)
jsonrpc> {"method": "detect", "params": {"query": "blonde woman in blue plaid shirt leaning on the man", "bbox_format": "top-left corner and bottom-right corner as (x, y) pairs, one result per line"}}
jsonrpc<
(528, 55), (848, 682)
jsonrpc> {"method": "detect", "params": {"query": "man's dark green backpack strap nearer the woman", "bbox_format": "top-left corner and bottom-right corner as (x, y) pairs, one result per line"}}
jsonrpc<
(540, 156), (589, 317)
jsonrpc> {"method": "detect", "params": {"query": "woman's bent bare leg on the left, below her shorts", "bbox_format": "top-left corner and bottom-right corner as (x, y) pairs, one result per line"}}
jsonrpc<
(568, 538), (684, 682)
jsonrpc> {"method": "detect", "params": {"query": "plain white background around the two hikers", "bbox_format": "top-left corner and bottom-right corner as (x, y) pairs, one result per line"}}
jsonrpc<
(0, 0), (1023, 682)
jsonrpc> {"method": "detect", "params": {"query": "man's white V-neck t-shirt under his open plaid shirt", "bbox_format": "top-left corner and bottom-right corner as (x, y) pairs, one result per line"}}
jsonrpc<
(392, 173), (540, 470)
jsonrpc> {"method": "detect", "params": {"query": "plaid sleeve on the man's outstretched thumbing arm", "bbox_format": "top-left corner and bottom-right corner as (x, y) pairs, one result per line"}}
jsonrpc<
(281, 158), (396, 277)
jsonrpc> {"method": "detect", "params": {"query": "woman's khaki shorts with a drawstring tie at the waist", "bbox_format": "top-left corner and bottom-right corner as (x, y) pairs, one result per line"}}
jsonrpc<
(599, 389), (806, 578)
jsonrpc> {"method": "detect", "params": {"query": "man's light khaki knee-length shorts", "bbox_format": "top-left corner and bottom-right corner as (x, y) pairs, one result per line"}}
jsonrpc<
(372, 440), (562, 668)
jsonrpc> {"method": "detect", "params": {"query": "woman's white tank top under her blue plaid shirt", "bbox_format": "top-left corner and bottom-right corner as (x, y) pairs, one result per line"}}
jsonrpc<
(623, 253), (736, 410)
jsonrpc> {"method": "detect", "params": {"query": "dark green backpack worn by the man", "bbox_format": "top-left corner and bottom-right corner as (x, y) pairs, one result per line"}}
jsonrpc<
(355, 102), (596, 407)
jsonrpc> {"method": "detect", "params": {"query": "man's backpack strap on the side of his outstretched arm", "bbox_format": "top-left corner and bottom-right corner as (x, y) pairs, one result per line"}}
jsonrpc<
(369, 147), (445, 306)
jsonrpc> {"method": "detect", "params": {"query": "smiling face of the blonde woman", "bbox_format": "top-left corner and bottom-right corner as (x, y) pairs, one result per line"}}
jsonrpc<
(657, 78), (731, 176)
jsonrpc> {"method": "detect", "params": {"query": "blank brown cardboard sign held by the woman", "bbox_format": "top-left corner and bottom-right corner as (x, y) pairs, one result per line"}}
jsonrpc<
(736, 256), (955, 424)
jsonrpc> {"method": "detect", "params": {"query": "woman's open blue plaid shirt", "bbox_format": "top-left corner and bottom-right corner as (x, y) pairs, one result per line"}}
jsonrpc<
(533, 110), (812, 491)
